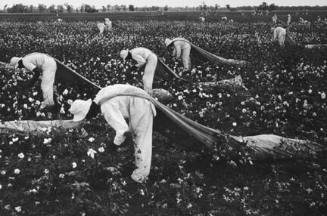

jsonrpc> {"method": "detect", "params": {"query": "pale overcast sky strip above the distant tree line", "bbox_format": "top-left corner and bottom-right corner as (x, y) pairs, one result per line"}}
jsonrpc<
(0, 0), (327, 8)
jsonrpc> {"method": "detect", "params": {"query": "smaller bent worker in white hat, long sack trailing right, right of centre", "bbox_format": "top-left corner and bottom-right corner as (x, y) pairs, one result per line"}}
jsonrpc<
(165, 38), (192, 72)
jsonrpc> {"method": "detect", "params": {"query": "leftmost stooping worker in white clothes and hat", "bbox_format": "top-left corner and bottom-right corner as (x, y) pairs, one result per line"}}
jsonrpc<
(9, 52), (57, 108)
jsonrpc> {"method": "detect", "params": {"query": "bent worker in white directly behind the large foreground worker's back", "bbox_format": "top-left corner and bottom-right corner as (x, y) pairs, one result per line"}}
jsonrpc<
(120, 47), (158, 94)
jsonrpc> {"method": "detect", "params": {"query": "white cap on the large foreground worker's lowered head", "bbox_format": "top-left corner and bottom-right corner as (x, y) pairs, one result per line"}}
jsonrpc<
(69, 99), (92, 121)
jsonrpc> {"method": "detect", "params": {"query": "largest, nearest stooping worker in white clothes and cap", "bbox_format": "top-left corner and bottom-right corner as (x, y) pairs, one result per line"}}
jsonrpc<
(69, 84), (156, 183)
